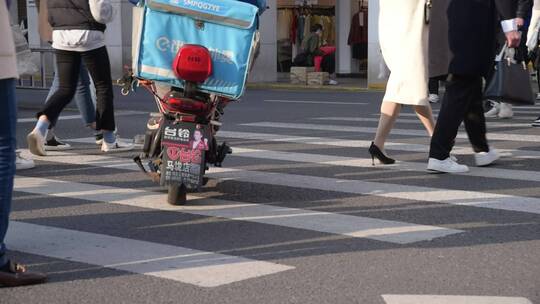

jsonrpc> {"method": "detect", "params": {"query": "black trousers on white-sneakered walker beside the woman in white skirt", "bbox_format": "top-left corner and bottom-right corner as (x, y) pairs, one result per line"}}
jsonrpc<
(429, 75), (489, 160)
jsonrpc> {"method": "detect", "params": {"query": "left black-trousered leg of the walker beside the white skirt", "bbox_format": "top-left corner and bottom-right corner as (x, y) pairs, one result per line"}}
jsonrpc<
(429, 75), (482, 160)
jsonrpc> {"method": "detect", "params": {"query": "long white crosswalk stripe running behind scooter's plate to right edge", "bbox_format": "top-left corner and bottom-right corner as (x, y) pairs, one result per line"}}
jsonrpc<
(23, 152), (540, 214)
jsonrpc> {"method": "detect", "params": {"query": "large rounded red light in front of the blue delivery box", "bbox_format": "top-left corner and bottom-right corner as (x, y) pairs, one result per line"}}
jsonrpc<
(172, 44), (212, 83)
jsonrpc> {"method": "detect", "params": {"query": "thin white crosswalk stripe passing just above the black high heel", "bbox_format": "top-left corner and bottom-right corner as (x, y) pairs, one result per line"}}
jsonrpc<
(241, 122), (540, 143)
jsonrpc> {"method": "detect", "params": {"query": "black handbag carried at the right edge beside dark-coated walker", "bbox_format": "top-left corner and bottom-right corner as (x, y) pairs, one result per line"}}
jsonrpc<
(484, 45), (535, 106)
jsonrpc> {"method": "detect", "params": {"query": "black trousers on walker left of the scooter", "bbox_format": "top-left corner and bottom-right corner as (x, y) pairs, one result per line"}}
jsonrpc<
(37, 47), (115, 131)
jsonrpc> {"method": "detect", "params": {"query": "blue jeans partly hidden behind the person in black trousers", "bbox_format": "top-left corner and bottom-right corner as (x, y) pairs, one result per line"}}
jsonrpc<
(45, 60), (96, 126)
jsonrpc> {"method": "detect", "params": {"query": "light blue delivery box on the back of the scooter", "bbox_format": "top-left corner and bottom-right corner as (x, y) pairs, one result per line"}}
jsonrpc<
(133, 0), (258, 99)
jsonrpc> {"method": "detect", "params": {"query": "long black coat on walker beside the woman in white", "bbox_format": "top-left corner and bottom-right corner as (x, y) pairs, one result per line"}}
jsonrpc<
(429, 0), (523, 77)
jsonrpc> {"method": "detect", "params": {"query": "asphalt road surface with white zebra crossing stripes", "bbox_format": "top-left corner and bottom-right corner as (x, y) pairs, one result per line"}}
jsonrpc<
(0, 86), (540, 304)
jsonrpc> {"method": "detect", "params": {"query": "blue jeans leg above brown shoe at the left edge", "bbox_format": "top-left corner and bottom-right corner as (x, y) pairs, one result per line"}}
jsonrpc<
(0, 79), (17, 266)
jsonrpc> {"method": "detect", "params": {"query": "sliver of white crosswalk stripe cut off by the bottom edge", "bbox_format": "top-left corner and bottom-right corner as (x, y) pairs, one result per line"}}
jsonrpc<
(382, 295), (532, 304)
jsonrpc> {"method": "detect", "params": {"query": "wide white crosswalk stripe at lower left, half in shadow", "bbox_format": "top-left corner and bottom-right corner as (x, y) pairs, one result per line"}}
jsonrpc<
(6, 221), (294, 287)
